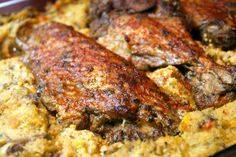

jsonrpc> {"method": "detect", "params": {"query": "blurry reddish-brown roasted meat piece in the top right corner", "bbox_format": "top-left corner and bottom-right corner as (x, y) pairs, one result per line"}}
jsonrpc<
(180, 0), (236, 49)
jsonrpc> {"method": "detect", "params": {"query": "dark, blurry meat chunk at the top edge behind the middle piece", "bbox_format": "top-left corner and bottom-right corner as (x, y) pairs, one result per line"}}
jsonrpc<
(89, 0), (156, 38)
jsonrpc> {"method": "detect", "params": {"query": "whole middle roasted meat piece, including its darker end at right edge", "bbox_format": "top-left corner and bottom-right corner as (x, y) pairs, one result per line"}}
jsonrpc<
(93, 12), (236, 109)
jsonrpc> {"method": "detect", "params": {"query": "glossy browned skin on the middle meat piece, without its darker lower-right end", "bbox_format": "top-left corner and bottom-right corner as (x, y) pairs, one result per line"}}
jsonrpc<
(98, 13), (197, 70)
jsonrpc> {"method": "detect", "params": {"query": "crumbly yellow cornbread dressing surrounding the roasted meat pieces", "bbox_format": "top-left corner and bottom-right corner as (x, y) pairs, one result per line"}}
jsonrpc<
(0, 0), (236, 157)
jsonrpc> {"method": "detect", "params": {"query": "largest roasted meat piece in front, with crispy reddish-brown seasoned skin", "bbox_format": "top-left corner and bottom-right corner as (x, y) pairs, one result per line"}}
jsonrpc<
(24, 23), (181, 142)
